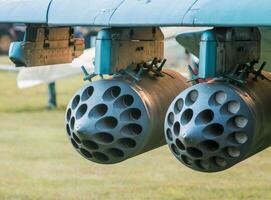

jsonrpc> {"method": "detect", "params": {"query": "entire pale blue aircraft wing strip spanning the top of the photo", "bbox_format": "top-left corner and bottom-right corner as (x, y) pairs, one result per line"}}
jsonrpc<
(0, 0), (271, 27)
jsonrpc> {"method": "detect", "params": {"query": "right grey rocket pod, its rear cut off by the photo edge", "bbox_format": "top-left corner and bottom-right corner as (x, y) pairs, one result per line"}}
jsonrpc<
(164, 74), (271, 172)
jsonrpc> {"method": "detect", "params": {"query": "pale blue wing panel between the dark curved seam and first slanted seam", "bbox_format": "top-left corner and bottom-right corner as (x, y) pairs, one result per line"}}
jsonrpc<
(48, 0), (123, 26)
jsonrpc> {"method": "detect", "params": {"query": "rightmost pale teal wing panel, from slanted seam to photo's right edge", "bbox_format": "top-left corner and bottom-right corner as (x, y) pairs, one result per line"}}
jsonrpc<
(185, 0), (271, 27)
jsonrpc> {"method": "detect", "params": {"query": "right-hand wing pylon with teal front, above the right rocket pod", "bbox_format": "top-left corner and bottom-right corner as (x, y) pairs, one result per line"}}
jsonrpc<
(198, 27), (261, 79)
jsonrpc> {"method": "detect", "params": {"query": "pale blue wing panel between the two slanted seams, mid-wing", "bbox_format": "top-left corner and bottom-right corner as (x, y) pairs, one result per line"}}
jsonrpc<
(110, 0), (197, 26)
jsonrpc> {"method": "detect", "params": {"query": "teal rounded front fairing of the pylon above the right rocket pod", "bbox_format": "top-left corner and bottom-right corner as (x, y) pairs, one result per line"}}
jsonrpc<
(198, 30), (217, 78)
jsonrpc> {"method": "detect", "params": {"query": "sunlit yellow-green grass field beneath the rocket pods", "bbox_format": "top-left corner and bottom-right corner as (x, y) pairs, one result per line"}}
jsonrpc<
(0, 72), (271, 200)
